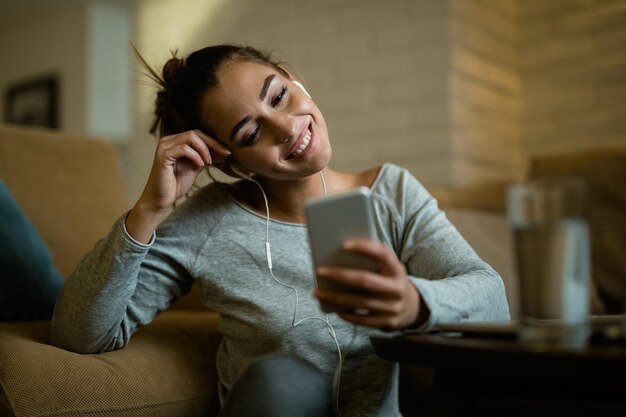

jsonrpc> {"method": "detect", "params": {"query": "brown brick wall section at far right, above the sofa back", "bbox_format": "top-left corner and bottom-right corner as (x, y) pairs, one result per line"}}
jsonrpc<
(520, 0), (626, 159)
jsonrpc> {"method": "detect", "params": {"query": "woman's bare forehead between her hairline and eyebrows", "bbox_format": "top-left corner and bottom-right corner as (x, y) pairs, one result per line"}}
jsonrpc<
(201, 61), (282, 143)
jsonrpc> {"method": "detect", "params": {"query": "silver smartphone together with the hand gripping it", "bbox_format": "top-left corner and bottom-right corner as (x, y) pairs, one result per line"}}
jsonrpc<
(306, 187), (428, 330)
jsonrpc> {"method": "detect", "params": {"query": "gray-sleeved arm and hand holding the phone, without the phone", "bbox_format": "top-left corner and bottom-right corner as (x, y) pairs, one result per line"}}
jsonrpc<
(316, 166), (509, 330)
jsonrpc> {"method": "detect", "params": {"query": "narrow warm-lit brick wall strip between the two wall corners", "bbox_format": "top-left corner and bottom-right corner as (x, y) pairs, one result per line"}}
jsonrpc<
(450, 0), (523, 184)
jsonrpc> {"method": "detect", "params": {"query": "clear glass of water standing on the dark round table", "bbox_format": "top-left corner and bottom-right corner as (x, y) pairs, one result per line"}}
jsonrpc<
(507, 177), (591, 347)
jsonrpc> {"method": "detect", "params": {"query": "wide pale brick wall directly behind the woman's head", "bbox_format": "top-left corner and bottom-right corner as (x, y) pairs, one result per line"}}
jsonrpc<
(133, 0), (452, 198)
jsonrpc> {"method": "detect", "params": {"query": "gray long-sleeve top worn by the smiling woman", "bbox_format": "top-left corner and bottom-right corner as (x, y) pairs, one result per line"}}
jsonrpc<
(52, 164), (509, 417)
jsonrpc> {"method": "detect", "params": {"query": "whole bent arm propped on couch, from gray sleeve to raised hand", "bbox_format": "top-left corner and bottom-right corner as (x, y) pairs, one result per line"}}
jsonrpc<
(52, 130), (229, 353)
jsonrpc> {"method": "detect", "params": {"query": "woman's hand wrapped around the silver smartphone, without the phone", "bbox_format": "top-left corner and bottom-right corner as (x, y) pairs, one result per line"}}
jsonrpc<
(315, 239), (429, 331)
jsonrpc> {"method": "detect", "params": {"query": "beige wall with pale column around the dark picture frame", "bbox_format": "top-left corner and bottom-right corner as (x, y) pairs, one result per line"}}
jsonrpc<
(0, 0), (133, 145)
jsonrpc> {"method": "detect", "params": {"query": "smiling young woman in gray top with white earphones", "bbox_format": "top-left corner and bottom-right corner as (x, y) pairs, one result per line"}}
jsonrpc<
(53, 45), (509, 417)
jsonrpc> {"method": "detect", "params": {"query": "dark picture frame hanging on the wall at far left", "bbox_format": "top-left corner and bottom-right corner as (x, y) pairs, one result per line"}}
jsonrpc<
(4, 75), (59, 129)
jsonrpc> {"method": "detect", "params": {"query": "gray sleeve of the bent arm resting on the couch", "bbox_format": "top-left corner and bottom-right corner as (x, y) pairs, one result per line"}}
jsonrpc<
(52, 216), (193, 353)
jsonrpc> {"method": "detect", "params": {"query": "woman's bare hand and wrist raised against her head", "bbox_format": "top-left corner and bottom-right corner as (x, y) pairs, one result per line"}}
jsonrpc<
(126, 130), (230, 243)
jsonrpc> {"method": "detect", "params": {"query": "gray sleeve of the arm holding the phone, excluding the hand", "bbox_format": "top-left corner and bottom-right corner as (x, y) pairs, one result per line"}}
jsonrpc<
(400, 190), (510, 330)
